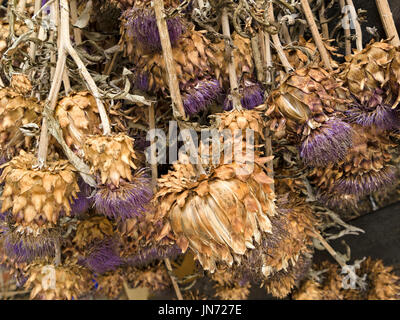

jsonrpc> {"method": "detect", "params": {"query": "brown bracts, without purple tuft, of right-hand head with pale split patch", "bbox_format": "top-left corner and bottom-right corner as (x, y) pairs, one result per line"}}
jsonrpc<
(266, 67), (348, 136)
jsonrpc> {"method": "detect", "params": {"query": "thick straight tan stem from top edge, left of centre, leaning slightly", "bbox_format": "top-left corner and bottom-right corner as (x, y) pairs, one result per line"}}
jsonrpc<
(154, 0), (186, 120)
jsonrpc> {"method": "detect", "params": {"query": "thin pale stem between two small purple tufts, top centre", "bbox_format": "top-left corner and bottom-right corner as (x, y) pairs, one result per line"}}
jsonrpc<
(221, 8), (242, 110)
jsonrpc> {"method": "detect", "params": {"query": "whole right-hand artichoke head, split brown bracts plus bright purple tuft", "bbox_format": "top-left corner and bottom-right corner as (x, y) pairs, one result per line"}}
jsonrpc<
(266, 67), (352, 166)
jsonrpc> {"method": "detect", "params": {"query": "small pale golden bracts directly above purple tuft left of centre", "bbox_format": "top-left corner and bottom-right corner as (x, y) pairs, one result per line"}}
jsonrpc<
(84, 133), (136, 187)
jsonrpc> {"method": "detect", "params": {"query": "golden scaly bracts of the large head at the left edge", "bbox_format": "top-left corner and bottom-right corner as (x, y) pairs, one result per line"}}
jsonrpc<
(0, 151), (79, 228)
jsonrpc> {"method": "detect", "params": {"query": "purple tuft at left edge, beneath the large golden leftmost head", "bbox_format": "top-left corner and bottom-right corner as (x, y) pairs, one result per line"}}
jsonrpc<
(3, 229), (60, 263)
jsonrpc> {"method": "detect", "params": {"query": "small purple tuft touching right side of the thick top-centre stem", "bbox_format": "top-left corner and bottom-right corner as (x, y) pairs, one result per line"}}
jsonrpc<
(183, 79), (221, 115)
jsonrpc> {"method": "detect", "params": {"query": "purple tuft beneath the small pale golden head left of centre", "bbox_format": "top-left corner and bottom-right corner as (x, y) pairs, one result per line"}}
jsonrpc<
(94, 171), (153, 220)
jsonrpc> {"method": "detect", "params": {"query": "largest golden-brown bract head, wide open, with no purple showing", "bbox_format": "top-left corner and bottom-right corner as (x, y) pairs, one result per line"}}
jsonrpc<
(155, 163), (276, 271)
